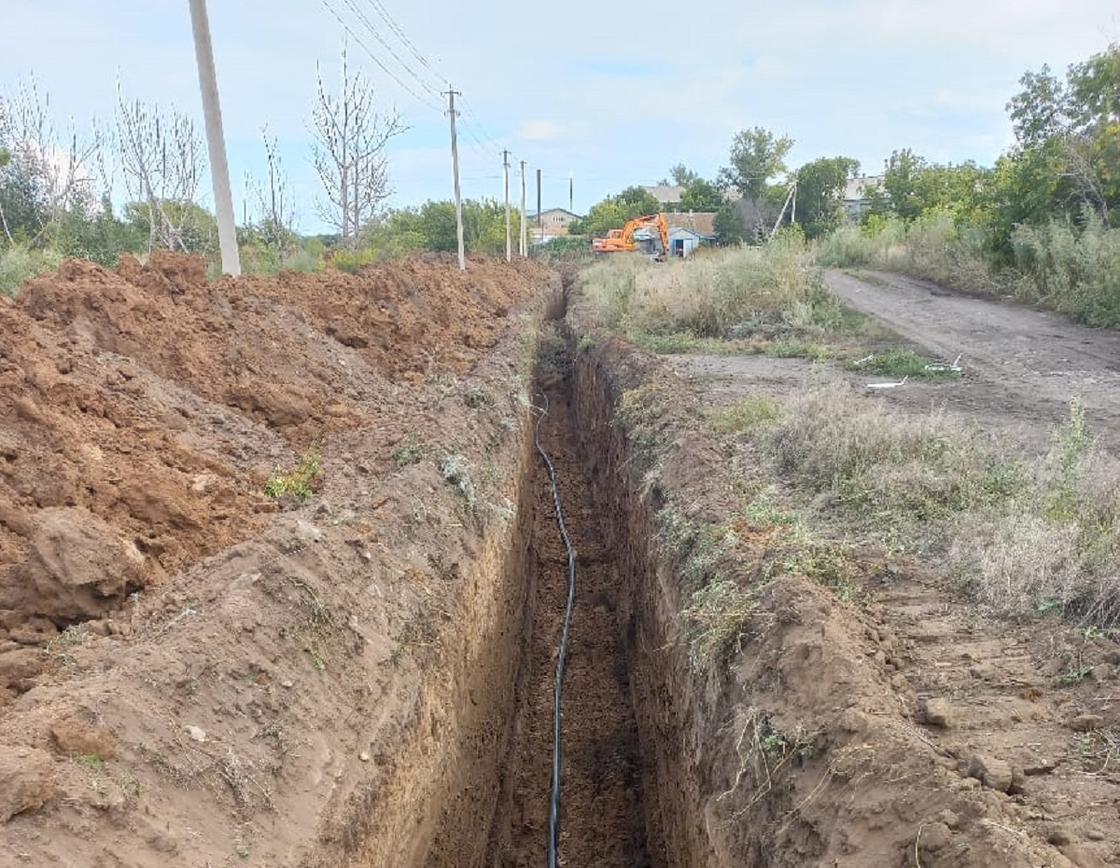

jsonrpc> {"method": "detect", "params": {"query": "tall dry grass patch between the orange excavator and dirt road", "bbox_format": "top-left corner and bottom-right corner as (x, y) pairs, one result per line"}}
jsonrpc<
(584, 233), (848, 338)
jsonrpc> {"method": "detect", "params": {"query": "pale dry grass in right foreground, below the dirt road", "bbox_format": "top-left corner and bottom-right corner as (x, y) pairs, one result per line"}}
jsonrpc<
(758, 386), (1120, 626)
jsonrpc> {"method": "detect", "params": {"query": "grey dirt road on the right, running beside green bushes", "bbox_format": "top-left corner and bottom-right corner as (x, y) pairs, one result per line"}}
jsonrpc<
(825, 271), (1120, 451)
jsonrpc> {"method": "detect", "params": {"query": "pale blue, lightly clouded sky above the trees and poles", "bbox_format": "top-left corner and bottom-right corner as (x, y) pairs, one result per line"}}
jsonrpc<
(0, 0), (1120, 232)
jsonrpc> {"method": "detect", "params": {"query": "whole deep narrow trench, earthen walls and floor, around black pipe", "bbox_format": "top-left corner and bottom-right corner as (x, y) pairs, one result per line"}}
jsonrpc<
(389, 309), (713, 868)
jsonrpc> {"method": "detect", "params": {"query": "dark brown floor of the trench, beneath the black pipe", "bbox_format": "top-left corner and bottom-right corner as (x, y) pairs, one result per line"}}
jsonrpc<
(486, 342), (651, 868)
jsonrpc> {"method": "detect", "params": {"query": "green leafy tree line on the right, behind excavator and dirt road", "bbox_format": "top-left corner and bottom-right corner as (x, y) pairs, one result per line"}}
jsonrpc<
(572, 45), (1120, 263)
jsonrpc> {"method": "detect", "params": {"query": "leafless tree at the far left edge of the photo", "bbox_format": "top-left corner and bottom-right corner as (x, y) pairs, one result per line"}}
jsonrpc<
(0, 76), (104, 244)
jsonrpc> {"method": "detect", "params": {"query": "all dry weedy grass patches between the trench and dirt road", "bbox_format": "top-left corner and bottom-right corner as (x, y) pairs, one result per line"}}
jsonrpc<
(584, 243), (1120, 662)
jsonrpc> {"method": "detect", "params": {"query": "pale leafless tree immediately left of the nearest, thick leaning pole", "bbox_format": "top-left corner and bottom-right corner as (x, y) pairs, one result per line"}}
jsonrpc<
(116, 92), (205, 252)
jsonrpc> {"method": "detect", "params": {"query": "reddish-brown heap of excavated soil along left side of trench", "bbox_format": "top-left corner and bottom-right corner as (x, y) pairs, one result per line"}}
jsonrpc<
(0, 253), (540, 703)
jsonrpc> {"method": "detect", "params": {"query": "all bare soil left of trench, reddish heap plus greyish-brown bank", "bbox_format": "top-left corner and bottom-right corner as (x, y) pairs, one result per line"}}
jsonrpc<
(0, 249), (559, 868)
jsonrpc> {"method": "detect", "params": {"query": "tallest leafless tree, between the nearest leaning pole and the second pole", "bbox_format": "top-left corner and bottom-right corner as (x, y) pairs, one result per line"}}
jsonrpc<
(311, 48), (407, 245)
